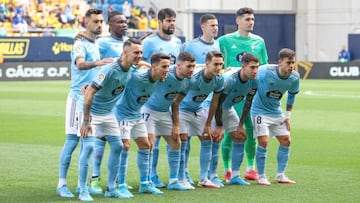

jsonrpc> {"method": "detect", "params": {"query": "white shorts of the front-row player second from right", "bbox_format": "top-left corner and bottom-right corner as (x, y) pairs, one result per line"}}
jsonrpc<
(211, 107), (240, 133)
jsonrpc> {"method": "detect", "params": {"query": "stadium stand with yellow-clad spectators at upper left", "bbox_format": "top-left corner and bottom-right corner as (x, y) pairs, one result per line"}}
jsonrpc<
(0, 0), (152, 37)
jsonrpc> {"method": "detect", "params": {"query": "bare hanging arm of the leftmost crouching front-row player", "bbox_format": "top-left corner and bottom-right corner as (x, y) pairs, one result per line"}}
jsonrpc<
(80, 85), (98, 138)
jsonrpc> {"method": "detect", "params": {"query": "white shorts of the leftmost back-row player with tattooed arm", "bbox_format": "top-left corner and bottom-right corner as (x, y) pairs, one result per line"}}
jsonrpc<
(65, 95), (79, 135)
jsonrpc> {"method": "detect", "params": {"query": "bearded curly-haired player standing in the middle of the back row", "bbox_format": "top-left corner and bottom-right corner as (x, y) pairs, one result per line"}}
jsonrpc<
(143, 8), (181, 188)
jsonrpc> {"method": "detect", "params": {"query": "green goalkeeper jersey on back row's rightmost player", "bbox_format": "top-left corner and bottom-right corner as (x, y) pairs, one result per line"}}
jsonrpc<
(218, 31), (268, 69)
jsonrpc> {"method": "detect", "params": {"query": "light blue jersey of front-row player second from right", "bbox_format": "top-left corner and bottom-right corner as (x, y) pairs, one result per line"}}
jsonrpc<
(222, 69), (258, 109)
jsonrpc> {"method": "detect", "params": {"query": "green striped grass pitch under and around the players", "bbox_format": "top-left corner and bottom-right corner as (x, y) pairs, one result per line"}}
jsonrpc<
(0, 80), (360, 203)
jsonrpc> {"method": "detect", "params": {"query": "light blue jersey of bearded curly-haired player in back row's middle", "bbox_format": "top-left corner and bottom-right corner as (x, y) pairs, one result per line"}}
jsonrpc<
(142, 33), (181, 64)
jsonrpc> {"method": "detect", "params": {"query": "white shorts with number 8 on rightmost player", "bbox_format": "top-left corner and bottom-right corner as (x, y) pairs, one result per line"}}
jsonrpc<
(252, 115), (290, 138)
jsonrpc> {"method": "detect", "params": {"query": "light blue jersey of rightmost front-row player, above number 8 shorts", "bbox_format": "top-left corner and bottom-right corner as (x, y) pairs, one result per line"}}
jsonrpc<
(251, 64), (300, 117)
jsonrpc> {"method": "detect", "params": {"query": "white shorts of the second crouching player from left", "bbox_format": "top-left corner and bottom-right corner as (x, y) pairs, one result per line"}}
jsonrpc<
(118, 119), (148, 140)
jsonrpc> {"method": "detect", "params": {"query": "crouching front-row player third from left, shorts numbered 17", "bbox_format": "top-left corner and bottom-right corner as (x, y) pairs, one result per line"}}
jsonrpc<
(142, 52), (195, 190)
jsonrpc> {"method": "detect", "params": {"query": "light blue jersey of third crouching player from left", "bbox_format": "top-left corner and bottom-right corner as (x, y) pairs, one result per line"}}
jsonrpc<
(145, 65), (189, 112)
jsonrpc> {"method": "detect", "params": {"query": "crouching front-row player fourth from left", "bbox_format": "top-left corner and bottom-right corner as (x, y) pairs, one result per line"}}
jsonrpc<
(172, 51), (224, 188)
